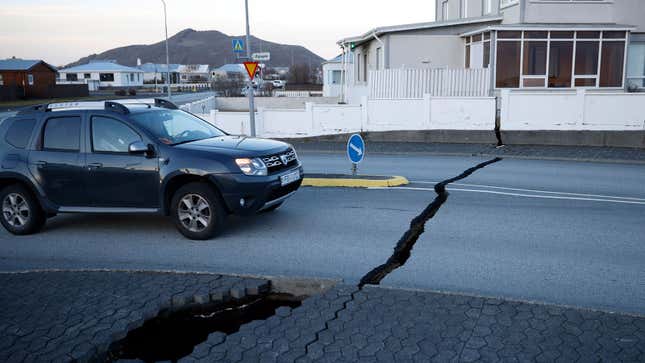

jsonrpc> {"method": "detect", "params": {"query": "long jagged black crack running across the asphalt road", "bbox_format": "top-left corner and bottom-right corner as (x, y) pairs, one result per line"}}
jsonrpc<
(358, 158), (502, 288)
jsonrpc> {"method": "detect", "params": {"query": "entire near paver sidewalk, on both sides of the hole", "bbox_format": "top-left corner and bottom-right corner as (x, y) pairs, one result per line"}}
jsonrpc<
(0, 271), (645, 362)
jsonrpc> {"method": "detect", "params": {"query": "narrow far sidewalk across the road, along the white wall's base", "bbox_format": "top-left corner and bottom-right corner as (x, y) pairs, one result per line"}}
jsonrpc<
(292, 141), (645, 164)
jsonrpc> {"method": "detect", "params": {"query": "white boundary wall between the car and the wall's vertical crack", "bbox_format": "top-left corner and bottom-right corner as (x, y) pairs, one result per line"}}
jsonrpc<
(209, 95), (495, 138)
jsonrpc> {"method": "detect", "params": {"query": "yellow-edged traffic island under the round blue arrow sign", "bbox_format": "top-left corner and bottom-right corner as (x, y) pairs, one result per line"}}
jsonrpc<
(302, 174), (410, 188)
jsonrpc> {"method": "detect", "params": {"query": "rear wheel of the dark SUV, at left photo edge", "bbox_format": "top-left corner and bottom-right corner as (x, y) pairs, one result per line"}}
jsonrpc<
(0, 185), (46, 235)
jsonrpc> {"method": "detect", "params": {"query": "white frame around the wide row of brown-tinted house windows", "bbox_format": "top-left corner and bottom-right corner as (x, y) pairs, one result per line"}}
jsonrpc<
(493, 29), (629, 90)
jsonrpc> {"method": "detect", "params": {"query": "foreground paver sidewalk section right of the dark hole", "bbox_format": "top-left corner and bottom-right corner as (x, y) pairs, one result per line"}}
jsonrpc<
(182, 286), (645, 362)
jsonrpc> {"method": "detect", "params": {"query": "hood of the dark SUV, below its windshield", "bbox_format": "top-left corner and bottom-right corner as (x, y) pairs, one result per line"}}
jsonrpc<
(177, 135), (290, 156)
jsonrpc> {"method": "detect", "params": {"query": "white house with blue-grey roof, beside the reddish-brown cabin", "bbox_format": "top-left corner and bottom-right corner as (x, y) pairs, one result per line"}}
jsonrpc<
(58, 61), (143, 87)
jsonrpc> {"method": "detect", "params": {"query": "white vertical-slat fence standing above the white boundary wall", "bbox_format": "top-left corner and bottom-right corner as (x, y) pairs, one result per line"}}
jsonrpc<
(368, 68), (490, 99)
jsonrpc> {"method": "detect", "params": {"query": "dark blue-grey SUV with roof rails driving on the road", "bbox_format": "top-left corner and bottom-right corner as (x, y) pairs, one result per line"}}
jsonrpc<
(0, 99), (303, 239)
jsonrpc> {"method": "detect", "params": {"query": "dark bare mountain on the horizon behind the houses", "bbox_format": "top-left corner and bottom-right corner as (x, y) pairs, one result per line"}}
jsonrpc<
(65, 29), (324, 67)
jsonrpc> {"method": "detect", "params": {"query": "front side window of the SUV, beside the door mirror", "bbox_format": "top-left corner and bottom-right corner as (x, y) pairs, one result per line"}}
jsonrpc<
(92, 116), (141, 153)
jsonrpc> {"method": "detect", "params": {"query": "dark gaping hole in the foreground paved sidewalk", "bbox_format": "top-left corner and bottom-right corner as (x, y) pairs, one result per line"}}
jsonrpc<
(107, 293), (305, 362)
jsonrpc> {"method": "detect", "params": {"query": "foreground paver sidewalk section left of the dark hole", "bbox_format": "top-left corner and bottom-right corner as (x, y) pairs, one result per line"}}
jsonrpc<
(0, 271), (269, 362)
